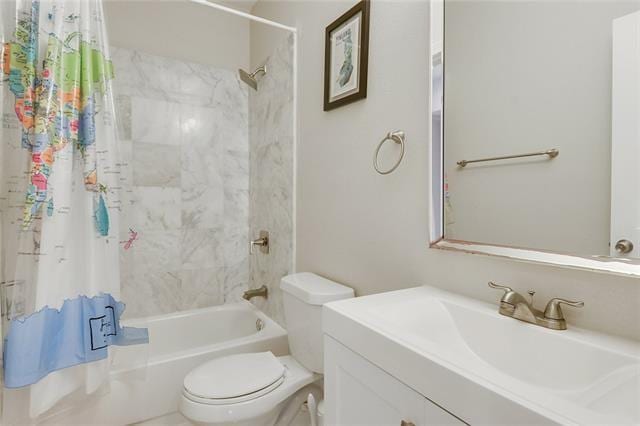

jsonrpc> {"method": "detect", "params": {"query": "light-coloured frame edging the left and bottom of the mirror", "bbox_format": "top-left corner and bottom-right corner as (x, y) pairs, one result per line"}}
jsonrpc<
(428, 0), (640, 278)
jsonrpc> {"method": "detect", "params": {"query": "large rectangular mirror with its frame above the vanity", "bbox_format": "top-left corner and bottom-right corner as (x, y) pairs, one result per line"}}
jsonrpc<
(431, 0), (640, 275)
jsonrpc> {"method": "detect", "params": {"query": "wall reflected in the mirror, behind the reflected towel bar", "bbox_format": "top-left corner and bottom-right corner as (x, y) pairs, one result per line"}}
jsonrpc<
(444, 0), (640, 256)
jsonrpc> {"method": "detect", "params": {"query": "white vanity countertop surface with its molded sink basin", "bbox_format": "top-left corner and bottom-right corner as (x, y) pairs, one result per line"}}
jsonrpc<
(327, 286), (640, 424)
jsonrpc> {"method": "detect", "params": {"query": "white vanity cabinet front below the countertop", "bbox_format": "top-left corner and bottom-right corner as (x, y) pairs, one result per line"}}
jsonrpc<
(324, 335), (464, 426)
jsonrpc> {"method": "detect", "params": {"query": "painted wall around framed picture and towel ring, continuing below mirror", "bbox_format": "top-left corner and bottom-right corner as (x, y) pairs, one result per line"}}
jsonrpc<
(253, 0), (640, 339)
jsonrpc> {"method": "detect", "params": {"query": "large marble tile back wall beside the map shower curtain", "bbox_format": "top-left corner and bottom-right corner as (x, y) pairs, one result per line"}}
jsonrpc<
(111, 48), (249, 317)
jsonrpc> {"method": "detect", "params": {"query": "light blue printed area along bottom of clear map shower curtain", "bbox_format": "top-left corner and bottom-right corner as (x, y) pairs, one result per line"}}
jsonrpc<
(4, 294), (149, 388)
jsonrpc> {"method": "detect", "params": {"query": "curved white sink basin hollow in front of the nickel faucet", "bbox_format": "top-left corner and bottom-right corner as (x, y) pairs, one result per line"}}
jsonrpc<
(443, 301), (637, 392)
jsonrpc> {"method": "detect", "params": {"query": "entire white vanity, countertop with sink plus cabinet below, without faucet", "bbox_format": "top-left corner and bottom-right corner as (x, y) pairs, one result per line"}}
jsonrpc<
(323, 286), (640, 426)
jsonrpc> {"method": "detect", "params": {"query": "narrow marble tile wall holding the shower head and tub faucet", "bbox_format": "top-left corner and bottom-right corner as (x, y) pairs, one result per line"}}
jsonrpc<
(249, 36), (294, 326)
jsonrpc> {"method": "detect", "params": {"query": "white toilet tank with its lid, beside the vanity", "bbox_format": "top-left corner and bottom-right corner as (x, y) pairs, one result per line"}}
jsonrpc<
(280, 272), (353, 373)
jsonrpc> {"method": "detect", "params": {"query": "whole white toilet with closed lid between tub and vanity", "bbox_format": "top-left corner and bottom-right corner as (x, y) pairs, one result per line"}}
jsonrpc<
(180, 272), (354, 426)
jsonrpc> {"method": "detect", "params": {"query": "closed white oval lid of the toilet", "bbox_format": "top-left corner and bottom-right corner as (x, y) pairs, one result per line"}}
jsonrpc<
(184, 352), (285, 399)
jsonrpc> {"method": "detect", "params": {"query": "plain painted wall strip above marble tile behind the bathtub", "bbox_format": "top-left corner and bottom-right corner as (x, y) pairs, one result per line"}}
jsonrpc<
(104, 0), (249, 70)
